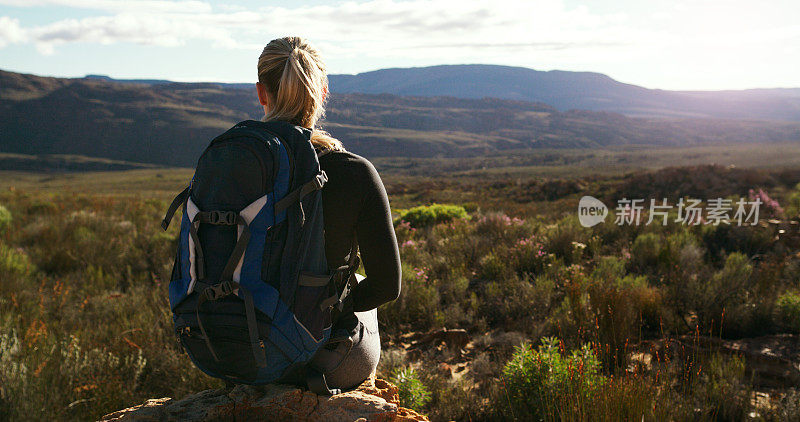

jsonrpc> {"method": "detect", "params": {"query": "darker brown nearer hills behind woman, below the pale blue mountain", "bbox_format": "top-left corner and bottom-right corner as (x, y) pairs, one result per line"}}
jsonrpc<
(0, 71), (800, 166)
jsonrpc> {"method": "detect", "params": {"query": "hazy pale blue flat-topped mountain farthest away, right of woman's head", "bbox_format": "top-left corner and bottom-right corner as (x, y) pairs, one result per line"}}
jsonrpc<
(330, 65), (800, 121)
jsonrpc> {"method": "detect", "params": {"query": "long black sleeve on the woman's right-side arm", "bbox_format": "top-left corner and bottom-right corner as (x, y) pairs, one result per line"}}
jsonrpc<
(352, 160), (401, 312)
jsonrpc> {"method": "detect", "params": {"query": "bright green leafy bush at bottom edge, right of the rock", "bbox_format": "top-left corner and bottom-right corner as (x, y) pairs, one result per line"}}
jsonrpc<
(503, 338), (606, 420)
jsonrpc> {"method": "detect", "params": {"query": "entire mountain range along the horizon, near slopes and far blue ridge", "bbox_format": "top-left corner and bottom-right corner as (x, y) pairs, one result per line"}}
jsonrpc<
(0, 66), (800, 166)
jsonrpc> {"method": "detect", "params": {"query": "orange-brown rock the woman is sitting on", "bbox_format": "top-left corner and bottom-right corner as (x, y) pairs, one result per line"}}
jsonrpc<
(101, 378), (428, 422)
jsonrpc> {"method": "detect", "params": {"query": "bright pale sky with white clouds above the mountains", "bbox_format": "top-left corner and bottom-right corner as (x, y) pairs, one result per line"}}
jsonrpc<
(0, 0), (800, 90)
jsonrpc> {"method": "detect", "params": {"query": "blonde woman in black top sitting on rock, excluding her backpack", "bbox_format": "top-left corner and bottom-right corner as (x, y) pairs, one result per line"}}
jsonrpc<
(256, 37), (400, 389)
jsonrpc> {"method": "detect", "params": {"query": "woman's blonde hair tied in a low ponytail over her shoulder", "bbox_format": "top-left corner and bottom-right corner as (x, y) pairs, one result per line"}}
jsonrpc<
(258, 37), (344, 151)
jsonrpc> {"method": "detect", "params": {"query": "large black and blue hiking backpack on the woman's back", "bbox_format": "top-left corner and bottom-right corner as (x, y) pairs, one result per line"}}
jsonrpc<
(162, 120), (360, 394)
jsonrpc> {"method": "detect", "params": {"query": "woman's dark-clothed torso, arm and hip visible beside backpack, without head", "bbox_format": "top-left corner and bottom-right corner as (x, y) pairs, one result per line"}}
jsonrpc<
(313, 151), (401, 388)
